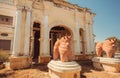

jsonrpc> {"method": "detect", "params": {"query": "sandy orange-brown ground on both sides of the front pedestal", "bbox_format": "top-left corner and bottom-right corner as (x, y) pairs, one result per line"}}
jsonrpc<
(0, 62), (120, 78)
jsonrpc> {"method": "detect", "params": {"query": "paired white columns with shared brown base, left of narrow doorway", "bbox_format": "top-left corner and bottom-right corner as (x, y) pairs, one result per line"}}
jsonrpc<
(9, 8), (32, 69)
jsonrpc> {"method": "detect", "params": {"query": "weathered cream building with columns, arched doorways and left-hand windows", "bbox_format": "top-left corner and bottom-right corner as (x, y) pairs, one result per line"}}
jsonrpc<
(0, 0), (95, 63)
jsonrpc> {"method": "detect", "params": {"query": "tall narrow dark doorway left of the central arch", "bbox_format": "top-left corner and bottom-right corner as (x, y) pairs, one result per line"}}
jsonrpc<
(33, 22), (40, 62)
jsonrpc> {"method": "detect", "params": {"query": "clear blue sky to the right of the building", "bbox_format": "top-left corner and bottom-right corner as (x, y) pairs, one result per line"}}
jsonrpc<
(68, 0), (120, 41)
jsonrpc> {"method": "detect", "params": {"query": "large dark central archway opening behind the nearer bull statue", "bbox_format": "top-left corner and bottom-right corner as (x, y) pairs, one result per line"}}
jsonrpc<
(49, 26), (72, 58)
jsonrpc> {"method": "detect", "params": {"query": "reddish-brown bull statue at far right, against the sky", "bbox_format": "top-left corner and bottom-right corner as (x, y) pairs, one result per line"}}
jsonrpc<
(96, 39), (117, 58)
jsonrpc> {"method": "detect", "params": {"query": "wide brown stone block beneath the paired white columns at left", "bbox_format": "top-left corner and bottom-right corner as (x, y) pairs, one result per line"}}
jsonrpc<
(9, 56), (32, 69)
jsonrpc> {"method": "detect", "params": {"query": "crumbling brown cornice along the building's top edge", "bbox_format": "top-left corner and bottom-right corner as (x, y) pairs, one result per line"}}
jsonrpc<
(0, 0), (96, 16)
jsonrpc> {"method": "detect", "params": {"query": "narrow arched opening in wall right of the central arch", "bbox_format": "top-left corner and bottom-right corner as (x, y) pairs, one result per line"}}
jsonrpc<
(79, 28), (85, 54)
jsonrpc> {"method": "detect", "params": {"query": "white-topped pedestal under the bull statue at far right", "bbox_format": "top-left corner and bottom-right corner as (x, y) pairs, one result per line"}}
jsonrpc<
(92, 57), (120, 73)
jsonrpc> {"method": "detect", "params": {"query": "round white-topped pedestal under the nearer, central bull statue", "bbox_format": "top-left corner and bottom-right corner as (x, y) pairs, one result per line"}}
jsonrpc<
(48, 60), (81, 78)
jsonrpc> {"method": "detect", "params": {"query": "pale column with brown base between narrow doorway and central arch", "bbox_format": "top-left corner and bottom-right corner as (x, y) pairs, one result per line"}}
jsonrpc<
(38, 13), (50, 63)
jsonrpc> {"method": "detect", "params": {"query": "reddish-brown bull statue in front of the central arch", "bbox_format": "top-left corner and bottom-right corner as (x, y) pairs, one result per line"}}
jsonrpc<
(53, 36), (72, 62)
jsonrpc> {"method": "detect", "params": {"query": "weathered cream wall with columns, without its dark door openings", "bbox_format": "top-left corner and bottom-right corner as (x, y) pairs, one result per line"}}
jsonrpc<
(0, 0), (95, 63)
